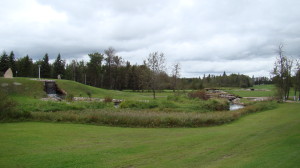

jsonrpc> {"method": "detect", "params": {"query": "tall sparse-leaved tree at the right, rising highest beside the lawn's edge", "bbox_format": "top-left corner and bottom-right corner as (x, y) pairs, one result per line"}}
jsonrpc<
(273, 44), (293, 101)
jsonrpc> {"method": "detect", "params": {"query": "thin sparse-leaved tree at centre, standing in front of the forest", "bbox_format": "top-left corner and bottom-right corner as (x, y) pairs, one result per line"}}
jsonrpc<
(146, 52), (165, 99)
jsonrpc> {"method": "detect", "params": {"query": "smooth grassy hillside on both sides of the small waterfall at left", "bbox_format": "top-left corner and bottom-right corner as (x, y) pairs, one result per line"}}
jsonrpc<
(0, 77), (173, 100)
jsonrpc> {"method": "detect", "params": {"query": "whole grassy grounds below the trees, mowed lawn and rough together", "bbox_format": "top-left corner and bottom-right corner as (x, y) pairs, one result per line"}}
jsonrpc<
(0, 78), (300, 168)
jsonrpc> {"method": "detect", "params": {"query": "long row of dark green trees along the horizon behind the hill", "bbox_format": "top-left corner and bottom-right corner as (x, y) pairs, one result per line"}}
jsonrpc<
(0, 47), (254, 92)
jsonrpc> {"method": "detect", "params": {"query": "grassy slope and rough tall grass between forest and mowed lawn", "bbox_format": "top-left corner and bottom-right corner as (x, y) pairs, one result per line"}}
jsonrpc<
(0, 78), (276, 127)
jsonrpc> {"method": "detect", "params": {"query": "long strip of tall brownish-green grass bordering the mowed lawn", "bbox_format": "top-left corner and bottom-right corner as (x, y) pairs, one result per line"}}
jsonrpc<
(30, 102), (277, 127)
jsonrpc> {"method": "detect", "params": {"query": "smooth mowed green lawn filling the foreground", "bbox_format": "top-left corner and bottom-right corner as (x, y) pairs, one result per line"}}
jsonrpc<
(0, 104), (300, 168)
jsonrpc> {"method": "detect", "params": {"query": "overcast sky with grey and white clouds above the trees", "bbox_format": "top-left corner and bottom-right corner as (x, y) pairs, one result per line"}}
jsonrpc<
(0, 0), (300, 77)
